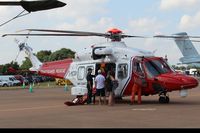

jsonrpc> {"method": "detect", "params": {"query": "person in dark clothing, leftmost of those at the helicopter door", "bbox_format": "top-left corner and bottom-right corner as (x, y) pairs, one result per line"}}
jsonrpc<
(86, 68), (95, 104)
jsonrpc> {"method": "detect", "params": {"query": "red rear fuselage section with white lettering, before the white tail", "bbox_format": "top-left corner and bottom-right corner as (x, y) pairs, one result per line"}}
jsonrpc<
(39, 59), (73, 78)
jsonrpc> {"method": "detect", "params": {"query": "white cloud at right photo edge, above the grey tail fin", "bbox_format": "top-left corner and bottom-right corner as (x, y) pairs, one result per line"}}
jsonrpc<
(179, 11), (200, 30)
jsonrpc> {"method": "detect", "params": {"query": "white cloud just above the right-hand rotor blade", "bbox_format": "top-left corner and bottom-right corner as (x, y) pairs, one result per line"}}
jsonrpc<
(129, 18), (164, 33)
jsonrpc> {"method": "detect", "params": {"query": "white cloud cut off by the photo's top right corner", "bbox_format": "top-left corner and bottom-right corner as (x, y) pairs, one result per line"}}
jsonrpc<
(160, 0), (200, 10)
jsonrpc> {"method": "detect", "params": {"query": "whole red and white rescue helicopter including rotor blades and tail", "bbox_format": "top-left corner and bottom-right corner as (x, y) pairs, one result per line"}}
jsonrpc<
(3, 29), (199, 104)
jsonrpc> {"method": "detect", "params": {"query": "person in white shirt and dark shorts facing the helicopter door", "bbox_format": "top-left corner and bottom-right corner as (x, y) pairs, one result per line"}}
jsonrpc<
(95, 69), (106, 105)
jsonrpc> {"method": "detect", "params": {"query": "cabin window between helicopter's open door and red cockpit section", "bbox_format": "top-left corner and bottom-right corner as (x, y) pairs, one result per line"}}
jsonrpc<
(118, 64), (128, 79)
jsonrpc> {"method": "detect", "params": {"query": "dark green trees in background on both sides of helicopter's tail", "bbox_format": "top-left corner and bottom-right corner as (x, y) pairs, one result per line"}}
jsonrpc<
(0, 48), (75, 75)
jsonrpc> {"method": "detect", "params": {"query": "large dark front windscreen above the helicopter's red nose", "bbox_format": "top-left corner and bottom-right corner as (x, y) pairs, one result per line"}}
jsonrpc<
(145, 60), (172, 78)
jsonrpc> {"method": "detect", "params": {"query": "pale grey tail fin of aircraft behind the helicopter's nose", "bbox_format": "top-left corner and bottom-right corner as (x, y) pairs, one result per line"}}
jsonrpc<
(174, 32), (200, 64)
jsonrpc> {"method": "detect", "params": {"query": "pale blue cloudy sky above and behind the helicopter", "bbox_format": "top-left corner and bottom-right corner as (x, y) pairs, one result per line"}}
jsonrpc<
(0, 0), (200, 64)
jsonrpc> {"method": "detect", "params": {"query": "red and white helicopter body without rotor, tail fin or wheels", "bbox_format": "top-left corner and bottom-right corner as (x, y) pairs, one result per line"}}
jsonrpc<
(33, 42), (198, 97)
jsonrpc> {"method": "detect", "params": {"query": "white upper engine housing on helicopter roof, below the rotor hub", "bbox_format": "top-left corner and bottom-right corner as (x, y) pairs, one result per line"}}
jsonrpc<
(75, 42), (154, 61)
